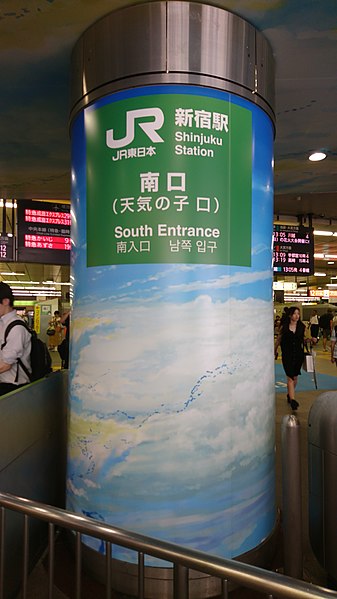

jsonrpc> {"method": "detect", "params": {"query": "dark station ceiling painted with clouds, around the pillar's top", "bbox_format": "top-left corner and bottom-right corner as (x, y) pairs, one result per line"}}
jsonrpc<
(0, 0), (337, 296)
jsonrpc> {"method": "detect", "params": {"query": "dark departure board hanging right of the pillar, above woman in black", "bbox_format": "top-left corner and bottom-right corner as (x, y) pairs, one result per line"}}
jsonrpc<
(273, 225), (314, 276)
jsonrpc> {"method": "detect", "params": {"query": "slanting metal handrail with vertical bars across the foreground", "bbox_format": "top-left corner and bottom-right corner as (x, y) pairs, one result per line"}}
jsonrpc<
(0, 493), (337, 599)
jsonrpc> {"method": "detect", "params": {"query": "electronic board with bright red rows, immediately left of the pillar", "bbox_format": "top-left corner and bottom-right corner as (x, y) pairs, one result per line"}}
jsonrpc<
(18, 200), (71, 265)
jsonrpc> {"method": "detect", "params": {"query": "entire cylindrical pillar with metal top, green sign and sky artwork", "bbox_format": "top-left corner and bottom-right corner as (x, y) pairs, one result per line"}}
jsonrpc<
(68, 1), (276, 592)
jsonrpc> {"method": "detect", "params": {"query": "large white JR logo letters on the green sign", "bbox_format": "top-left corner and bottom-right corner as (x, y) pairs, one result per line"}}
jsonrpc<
(106, 108), (164, 150)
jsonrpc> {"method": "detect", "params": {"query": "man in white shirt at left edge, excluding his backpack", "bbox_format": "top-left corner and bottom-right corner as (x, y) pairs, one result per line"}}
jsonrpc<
(0, 282), (32, 395)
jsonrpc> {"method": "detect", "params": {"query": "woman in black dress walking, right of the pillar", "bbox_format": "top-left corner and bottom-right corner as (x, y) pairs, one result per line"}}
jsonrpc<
(275, 306), (305, 410)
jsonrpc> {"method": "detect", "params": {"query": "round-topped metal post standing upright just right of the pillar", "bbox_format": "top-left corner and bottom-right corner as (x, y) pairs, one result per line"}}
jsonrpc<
(281, 414), (303, 579)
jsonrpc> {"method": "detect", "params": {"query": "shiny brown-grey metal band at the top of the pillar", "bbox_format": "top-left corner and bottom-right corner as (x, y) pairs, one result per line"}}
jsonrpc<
(71, 0), (274, 122)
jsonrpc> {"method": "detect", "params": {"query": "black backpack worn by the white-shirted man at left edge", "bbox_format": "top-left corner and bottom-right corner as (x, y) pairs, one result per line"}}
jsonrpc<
(1, 320), (52, 383)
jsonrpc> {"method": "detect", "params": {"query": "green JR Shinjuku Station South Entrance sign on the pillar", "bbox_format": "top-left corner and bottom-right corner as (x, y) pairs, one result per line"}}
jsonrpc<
(85, 89), (252, 266)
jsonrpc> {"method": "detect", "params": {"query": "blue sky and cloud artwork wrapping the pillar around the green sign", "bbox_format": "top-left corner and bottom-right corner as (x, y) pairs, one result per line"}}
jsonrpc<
(67, 86), (276, 564)
